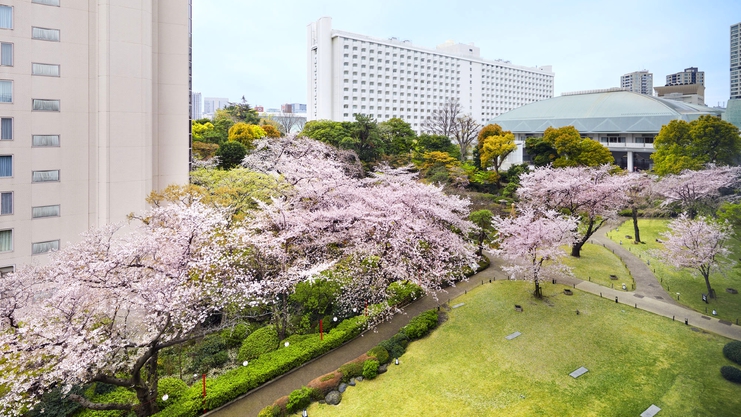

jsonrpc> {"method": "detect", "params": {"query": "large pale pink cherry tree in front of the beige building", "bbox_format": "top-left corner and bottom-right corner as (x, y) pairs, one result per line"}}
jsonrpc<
(0, 201), (260, 416)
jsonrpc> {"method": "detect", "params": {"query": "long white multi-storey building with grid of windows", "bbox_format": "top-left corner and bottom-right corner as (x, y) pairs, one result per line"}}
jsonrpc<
(307, 17), (554, 131)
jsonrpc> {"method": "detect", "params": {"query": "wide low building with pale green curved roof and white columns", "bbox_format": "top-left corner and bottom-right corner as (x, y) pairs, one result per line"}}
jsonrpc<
(489, 89), (723, 171)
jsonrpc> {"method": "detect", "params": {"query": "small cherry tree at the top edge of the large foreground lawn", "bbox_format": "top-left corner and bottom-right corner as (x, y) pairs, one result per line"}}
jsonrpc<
(492, 206), (578, 298)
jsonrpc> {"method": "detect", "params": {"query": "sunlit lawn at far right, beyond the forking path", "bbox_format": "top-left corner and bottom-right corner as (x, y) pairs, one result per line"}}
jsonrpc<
(608, 219), (741, 323)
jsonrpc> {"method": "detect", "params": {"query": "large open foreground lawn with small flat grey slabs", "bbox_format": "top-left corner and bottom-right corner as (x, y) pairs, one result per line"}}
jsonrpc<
(308, 281), (741, 417)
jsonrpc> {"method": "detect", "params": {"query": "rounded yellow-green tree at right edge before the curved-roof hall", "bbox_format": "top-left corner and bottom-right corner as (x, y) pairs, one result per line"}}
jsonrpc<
(651, 115), (741, 175)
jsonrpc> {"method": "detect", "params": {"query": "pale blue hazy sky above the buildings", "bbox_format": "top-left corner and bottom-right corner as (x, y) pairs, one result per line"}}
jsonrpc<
(193, 0), (741, 108)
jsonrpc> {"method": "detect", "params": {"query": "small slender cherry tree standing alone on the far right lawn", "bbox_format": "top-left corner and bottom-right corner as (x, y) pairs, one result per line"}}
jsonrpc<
(660, 214), (732, 298)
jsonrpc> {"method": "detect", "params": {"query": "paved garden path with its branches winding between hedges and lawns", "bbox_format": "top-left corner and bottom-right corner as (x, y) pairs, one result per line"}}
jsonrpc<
(208, 230), (741, 417)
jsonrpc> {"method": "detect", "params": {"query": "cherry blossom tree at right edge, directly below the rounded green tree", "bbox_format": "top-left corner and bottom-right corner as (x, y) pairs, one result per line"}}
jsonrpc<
(656, 165), (741, 218)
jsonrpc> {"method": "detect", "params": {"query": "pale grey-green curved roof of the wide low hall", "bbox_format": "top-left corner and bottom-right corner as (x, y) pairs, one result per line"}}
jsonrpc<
(490, 91), (722, 133)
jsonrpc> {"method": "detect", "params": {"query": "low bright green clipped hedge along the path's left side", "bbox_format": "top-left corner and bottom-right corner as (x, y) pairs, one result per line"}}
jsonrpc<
(155, 316), (368, 417)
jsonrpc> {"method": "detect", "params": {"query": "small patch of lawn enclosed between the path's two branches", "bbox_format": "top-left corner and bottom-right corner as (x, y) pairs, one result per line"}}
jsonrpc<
(561, 243), (634, 290)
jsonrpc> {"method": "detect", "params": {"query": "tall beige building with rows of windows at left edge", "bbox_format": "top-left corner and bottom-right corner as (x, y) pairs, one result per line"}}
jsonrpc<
(0, 0), (191, 272)
